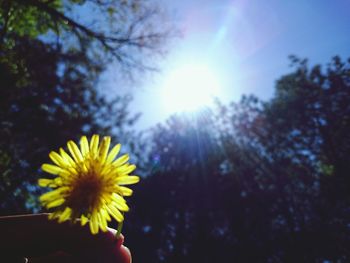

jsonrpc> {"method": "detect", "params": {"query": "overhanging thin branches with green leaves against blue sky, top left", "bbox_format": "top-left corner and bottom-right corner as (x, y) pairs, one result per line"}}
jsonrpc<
(0, 0), (171, 70)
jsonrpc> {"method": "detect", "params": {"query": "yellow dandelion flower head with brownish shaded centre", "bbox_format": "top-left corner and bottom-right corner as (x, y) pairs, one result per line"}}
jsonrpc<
(39, 135), (139, 234)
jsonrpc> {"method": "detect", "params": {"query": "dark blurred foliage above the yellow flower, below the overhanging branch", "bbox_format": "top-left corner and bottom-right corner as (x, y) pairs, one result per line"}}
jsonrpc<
(0, 34), (141, 211)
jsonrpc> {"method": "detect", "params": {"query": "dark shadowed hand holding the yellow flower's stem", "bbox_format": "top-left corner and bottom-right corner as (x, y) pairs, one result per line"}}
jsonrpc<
(0, 214), (131, 263)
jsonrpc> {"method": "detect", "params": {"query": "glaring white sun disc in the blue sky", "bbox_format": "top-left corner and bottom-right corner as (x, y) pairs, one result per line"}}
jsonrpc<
(162, 64), (220, 113)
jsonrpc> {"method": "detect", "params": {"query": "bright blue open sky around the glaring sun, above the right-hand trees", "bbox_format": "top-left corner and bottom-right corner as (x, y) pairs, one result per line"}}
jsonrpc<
(101, 0), (350, 129)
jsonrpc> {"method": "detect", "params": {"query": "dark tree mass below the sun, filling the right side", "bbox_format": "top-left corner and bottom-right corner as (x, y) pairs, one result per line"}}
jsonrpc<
(126, 58), (350, 262)
